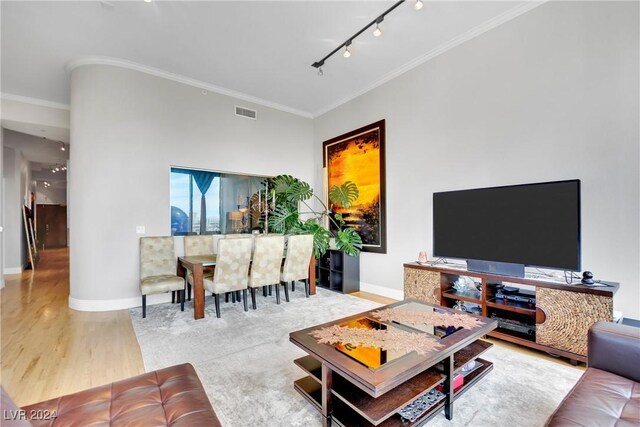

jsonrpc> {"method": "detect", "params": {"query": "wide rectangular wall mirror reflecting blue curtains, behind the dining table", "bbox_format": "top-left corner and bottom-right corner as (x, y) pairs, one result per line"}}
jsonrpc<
(170, 167), (267, 236)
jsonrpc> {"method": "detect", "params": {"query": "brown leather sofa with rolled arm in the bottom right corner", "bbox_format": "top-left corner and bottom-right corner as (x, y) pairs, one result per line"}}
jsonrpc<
(546, 322), (640, 427)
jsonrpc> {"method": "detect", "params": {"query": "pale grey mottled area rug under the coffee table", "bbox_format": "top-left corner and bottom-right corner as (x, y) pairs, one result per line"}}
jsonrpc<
(130, 287), (582, 427)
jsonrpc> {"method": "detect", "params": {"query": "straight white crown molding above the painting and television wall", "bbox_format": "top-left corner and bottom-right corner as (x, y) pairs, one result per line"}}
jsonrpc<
(313, 0), (550, 118)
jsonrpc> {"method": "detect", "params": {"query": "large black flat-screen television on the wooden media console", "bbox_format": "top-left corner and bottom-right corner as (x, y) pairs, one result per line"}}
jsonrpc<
(433, 179), (580, 277)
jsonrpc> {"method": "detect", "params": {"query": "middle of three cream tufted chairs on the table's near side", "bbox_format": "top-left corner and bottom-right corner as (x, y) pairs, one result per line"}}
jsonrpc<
(249, 235), (289, 310)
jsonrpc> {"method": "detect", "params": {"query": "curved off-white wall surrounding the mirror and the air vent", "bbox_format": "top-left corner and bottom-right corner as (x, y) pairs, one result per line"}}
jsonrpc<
(69, 65), (313, 310)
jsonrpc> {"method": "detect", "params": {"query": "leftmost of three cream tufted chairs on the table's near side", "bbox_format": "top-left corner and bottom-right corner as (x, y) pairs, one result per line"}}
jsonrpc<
(203, 239), (251, 317)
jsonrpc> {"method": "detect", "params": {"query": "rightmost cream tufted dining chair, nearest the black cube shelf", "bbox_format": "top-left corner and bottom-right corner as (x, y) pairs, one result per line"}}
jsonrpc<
(276, 234), (313, 302)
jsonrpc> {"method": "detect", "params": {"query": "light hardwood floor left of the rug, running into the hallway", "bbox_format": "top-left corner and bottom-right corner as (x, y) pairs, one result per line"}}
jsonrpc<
(0, 248), (144, 406)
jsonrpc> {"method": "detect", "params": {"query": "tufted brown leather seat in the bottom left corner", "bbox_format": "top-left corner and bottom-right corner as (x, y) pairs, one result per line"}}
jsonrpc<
(0, 363), (220, 427)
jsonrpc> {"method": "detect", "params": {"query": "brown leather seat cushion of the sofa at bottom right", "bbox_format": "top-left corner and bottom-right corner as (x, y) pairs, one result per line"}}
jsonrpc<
(547, 368), (640, 427)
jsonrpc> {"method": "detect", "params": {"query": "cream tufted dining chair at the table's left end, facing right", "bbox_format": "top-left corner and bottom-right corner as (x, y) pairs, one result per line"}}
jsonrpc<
(140, 237), (185, 318)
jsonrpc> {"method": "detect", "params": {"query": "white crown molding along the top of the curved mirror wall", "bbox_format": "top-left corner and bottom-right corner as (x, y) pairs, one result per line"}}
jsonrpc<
(65, 56), (313, 119)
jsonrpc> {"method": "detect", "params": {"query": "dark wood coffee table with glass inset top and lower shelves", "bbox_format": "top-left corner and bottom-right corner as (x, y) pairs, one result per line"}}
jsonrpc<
(289, 299), (497, 427)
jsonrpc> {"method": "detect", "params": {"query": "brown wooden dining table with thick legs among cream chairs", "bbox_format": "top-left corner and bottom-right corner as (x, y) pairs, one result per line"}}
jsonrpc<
(177, 254), (316, 320)
